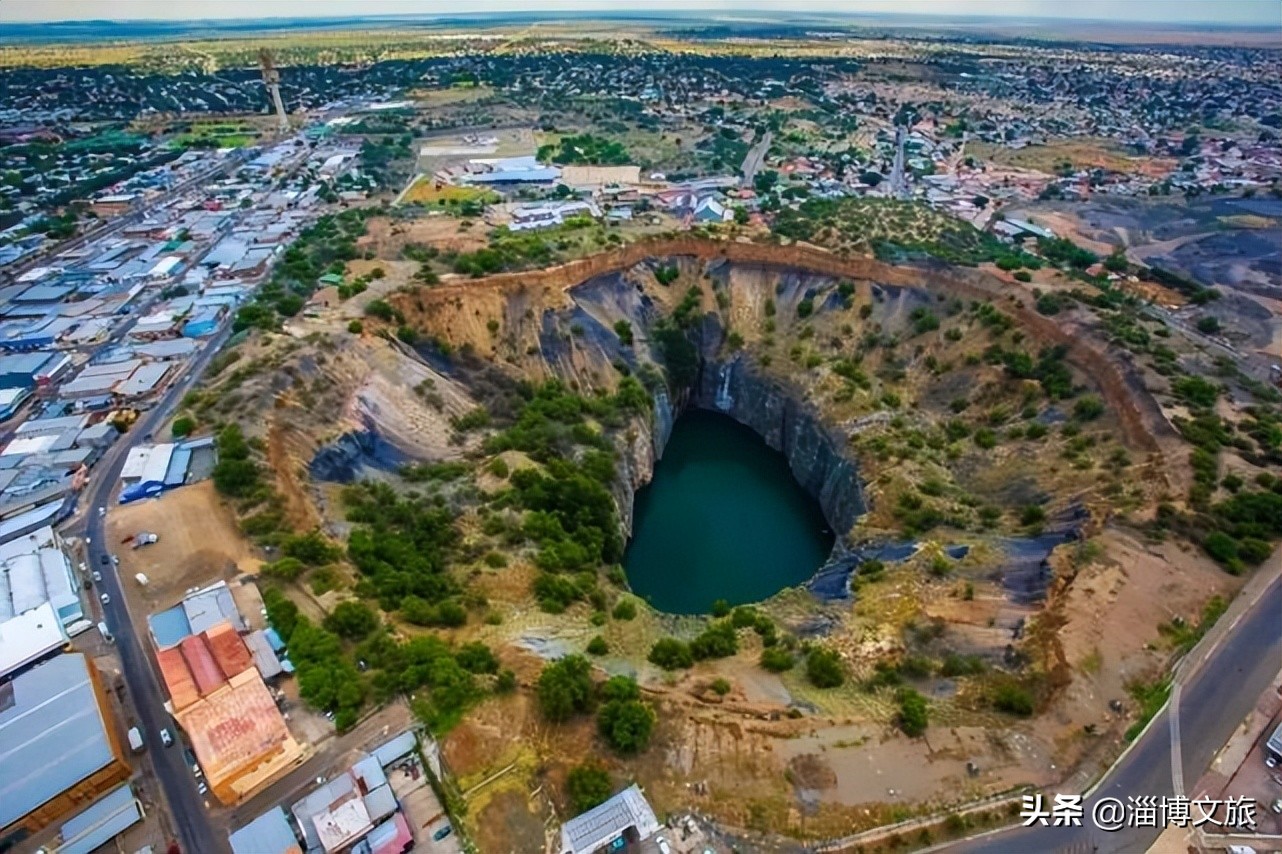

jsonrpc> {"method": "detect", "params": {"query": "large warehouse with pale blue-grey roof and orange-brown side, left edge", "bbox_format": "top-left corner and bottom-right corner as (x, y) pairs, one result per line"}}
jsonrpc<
(0, 653), (131, 844)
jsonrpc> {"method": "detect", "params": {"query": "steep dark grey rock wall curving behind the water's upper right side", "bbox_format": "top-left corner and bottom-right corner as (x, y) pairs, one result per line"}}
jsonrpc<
(688, 359), (865, 537)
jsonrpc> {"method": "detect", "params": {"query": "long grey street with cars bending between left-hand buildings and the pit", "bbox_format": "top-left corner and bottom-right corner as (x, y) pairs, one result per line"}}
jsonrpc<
(79, 321), (238, 854)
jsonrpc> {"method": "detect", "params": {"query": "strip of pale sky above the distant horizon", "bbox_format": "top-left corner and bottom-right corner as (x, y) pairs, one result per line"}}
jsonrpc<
(0, 0), (1282, 27)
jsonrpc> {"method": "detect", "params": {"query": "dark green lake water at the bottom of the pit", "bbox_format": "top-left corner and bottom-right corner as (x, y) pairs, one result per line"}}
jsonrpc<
(623, 410), (832, 614)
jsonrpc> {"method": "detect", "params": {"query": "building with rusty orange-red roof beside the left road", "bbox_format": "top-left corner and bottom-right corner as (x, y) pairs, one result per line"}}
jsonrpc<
(156, 621), (304, 804)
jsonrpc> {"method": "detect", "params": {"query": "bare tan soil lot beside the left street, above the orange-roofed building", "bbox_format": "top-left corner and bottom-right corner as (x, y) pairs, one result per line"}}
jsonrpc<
(106, 481), (262, 613)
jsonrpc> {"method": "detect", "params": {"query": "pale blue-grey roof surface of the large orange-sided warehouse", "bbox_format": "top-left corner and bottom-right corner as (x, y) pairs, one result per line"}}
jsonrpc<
(0, 653), (113, 827)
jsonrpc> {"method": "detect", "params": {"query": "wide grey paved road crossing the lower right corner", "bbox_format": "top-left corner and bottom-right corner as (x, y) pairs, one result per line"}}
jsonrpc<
(946, 577), (1282, 854)
